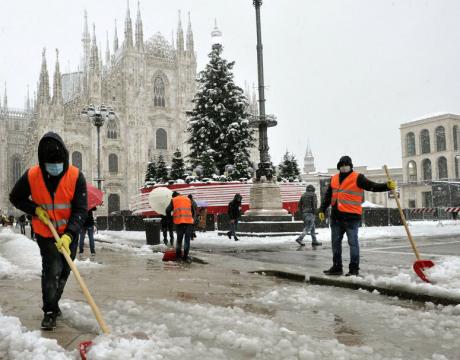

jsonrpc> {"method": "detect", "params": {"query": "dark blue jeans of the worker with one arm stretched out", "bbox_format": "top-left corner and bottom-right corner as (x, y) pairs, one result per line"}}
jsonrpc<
(331, 219), (361, 270)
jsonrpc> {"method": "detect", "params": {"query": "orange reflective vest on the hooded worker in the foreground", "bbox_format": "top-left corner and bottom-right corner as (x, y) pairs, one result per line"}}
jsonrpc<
(27, 165), (79, 238)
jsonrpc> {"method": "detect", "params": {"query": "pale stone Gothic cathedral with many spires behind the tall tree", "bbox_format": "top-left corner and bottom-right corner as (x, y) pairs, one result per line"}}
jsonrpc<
(0, 3), (196, 213)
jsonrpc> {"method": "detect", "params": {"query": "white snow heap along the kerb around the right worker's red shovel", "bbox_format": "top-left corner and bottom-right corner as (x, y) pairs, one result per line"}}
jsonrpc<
(347, 257), (460, 297)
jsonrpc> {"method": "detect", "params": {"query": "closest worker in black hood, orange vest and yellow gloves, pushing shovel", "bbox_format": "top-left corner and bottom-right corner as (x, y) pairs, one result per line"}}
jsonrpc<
(10, 132), (88, 330)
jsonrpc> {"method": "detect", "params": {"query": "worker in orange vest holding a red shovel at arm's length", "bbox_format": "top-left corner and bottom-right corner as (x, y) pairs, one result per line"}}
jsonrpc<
(318, 155), (396, 276)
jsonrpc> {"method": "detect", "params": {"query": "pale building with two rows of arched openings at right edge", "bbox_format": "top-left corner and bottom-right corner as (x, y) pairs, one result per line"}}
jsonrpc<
(400, 114), (460, 207)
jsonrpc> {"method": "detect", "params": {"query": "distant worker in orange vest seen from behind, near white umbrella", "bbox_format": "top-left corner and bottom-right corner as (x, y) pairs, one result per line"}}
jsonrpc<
(166, 191), (195, 263)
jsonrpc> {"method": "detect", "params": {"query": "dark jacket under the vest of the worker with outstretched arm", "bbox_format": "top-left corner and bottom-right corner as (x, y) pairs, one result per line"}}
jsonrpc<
(320, 170), (390, 221)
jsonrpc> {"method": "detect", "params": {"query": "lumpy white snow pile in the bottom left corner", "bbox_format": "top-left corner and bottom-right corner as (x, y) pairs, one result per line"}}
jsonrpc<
(0, 309), (72, 360)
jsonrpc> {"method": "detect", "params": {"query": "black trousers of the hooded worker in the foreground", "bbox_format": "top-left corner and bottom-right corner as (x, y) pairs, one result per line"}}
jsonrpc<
(36, 235), (78, 313)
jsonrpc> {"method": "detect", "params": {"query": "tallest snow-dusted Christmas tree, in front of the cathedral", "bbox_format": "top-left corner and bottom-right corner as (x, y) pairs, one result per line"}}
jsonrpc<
(187, 44), (254, 173)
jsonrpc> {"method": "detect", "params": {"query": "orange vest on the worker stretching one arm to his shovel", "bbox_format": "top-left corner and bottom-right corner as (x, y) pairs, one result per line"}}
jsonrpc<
(331, 171), (364, 215)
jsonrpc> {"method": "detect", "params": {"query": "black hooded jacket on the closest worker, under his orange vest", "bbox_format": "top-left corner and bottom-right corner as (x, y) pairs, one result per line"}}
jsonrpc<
(10, 132), (88, 240)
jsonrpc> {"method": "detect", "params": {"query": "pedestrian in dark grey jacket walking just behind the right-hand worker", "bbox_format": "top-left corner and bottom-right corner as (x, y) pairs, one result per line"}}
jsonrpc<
(295, 185), (321, 246)
